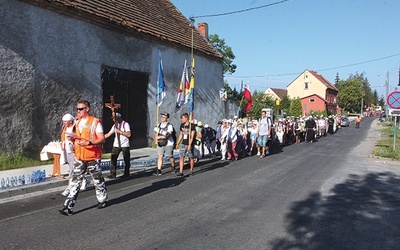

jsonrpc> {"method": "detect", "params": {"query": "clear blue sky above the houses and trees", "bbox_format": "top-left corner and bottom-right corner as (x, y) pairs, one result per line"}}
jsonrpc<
(171, 0), (400, 99)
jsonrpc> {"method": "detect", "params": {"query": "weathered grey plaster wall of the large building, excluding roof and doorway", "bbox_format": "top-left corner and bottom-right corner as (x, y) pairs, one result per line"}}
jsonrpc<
(0, 0), (223, 153)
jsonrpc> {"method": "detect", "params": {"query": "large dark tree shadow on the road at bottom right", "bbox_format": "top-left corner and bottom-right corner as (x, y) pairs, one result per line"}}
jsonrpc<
(270, 172), (400, 249)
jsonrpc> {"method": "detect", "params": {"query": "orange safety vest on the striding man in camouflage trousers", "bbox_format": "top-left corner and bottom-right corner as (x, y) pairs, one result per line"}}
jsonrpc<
(75, 116), (102, 161)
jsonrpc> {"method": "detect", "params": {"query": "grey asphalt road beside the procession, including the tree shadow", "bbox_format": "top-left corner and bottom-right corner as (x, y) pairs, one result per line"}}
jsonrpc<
(0, 118), (400, 250)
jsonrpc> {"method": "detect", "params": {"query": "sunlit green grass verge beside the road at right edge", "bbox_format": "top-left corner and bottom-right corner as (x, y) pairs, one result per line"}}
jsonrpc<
(372, 122), (400, 160)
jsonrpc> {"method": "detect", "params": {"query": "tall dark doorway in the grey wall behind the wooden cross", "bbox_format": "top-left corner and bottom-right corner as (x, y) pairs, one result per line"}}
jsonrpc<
(101, 65), (149, 152)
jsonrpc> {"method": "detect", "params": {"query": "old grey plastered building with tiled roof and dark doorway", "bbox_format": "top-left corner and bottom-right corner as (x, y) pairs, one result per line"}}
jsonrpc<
(0, 0), (224, 153)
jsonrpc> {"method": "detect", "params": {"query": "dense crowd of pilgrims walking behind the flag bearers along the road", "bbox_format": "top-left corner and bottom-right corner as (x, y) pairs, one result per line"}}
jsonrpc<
(192, 110), (341, 160)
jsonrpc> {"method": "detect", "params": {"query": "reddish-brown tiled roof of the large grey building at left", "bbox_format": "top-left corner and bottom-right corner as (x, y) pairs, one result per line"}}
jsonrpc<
(23, 0), (222, 59)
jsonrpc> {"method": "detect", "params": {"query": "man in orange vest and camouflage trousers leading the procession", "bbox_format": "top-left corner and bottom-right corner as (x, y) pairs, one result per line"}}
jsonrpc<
(59, 100), (108, 215)
